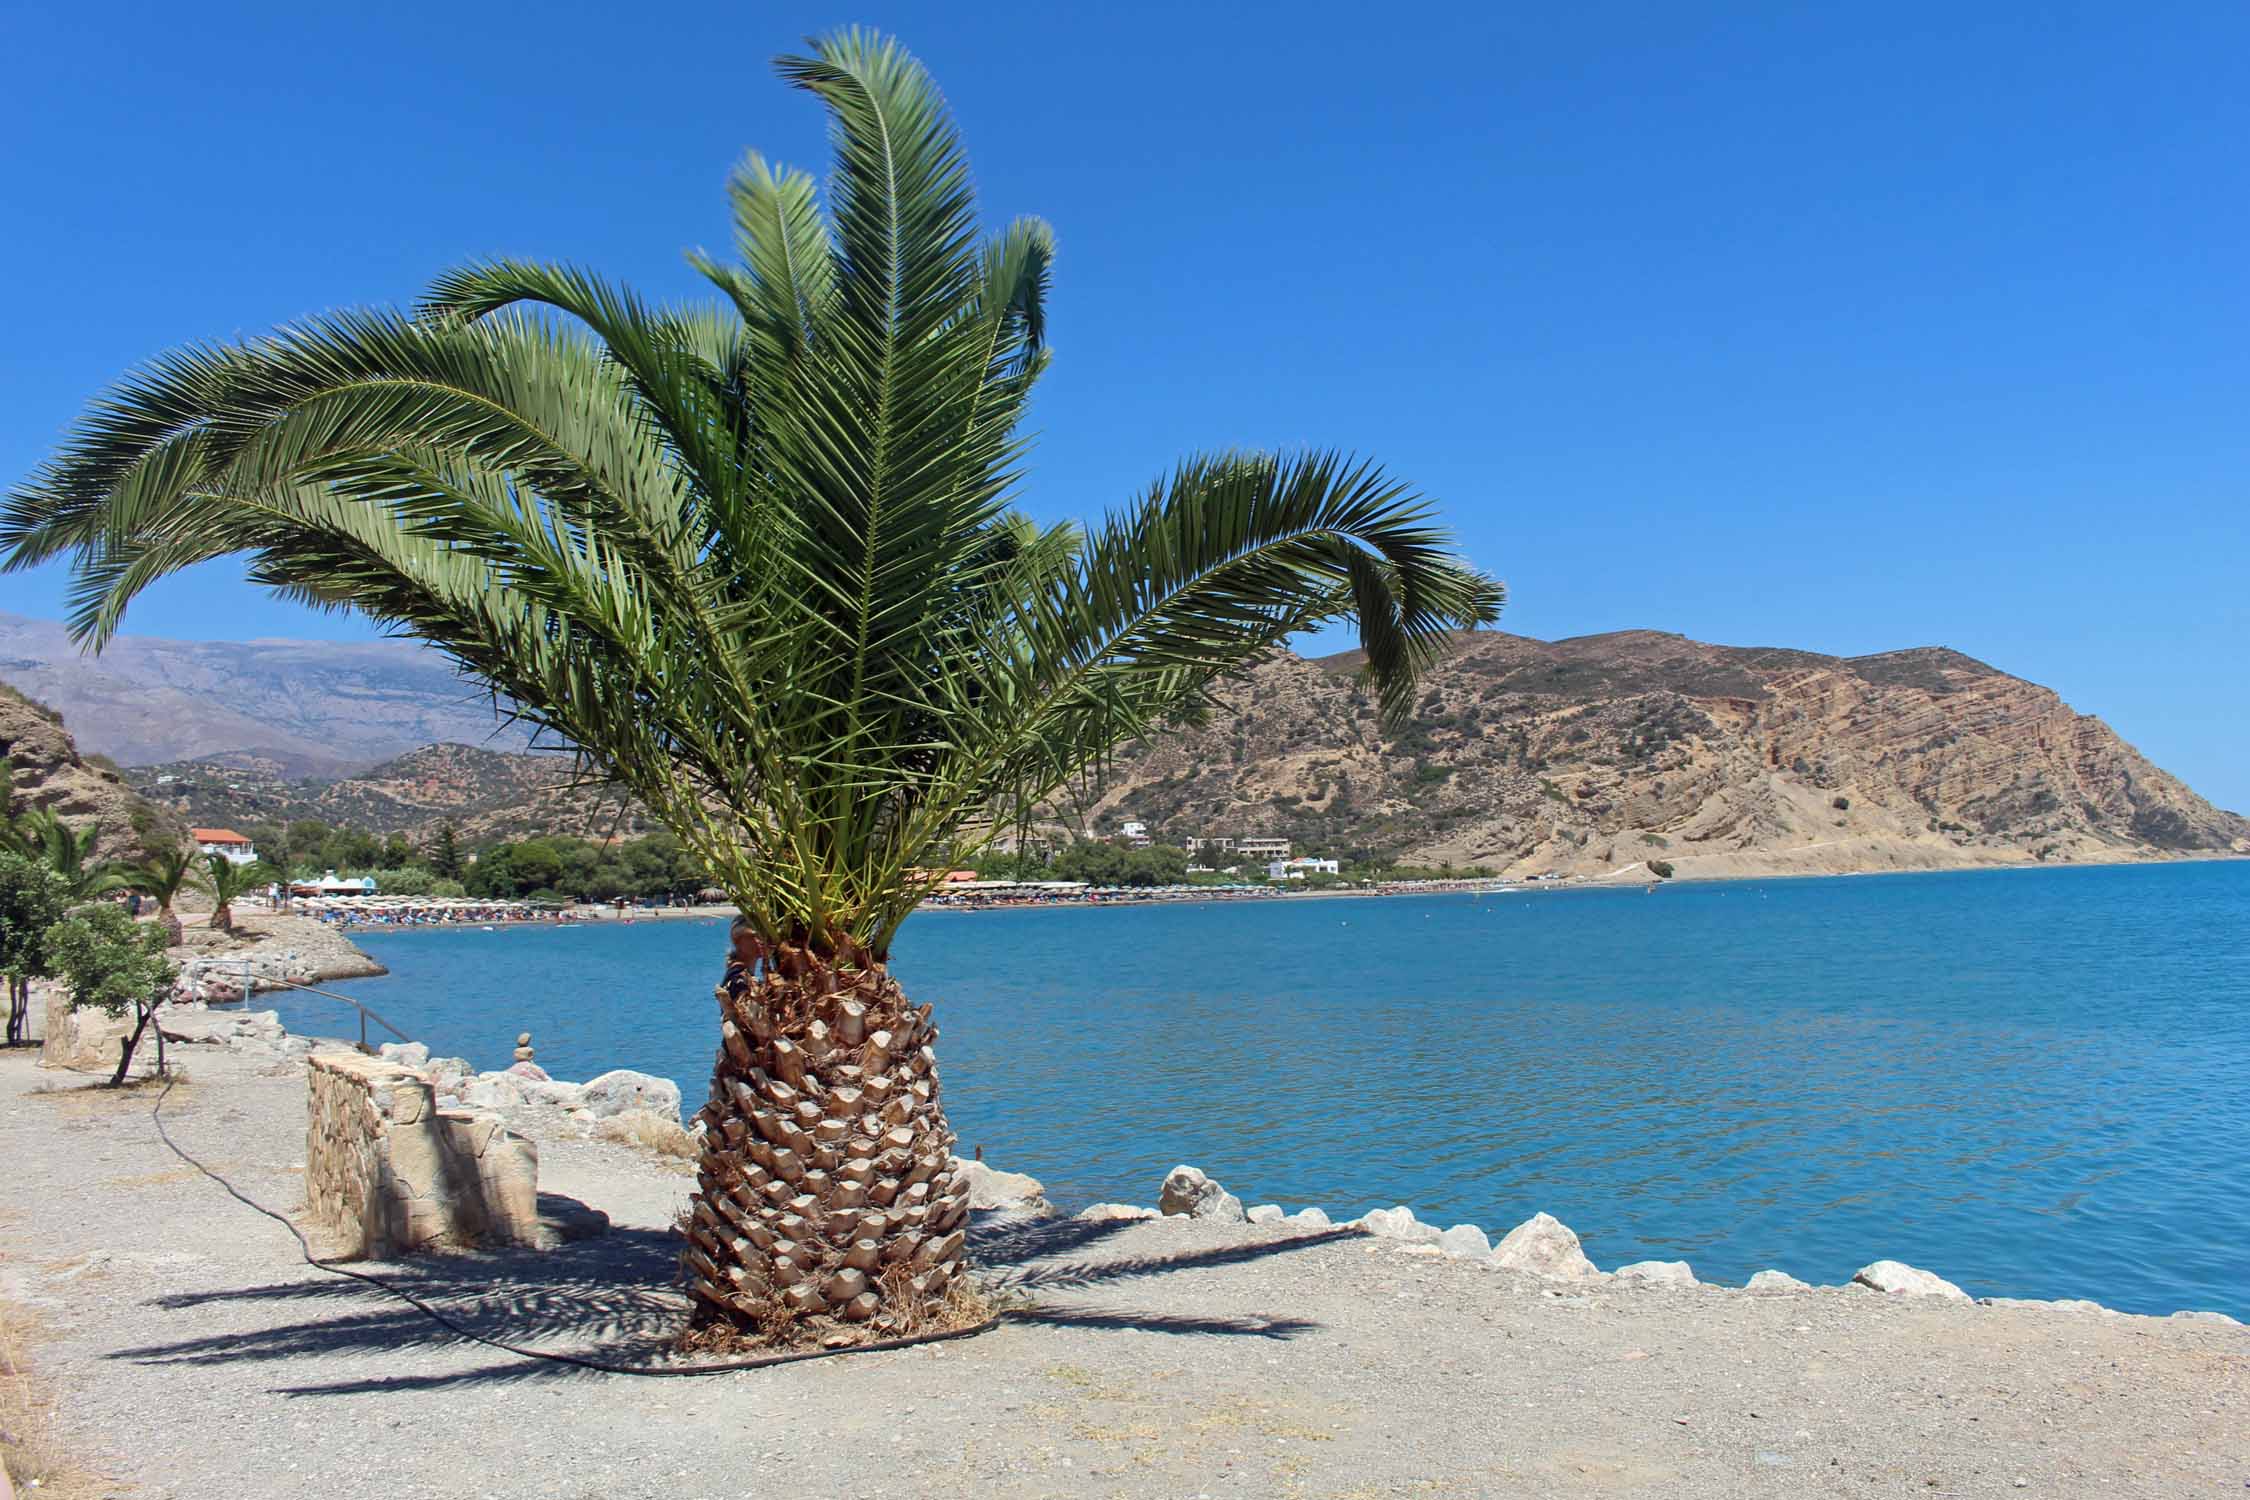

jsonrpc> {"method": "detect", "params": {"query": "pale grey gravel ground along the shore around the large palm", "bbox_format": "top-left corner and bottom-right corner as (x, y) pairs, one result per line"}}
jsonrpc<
(0, 1046), (2250, 1500)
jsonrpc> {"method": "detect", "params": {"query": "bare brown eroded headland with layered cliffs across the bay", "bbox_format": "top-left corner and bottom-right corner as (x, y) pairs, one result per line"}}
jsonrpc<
(1091, 632), (2250, 877)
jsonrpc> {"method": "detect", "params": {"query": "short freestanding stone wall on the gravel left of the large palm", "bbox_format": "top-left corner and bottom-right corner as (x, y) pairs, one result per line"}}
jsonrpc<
(304, 1052), (540, 1259)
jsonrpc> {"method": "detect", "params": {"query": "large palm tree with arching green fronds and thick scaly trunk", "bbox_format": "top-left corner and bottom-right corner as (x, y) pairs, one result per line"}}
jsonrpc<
(13, 31), (1501, 1331)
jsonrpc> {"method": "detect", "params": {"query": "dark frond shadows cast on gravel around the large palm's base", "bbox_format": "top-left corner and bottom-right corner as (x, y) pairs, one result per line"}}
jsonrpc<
(108, 1196), (1341, 1397)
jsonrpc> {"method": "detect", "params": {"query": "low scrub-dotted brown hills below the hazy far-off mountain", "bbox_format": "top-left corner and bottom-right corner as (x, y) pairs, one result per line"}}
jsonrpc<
(126, 744), (650, 843)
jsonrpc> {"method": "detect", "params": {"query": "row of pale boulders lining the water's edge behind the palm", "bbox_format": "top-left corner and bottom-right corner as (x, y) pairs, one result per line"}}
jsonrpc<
(180, 1012), (2241, 1327)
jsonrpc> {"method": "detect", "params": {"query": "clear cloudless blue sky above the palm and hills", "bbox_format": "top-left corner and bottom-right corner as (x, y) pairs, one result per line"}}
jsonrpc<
(0, 0), (2250, 810)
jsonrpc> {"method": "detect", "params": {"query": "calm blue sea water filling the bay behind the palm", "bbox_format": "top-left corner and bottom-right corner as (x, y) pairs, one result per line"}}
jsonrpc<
(290, 864), (2250, 1318)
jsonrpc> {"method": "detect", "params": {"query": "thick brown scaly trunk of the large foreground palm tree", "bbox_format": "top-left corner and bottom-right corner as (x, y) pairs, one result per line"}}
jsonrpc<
(682, 949), (970, 1340)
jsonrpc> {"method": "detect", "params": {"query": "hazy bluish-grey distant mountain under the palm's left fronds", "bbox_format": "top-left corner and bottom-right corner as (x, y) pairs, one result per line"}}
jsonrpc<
(0, 614), (529, 776)
